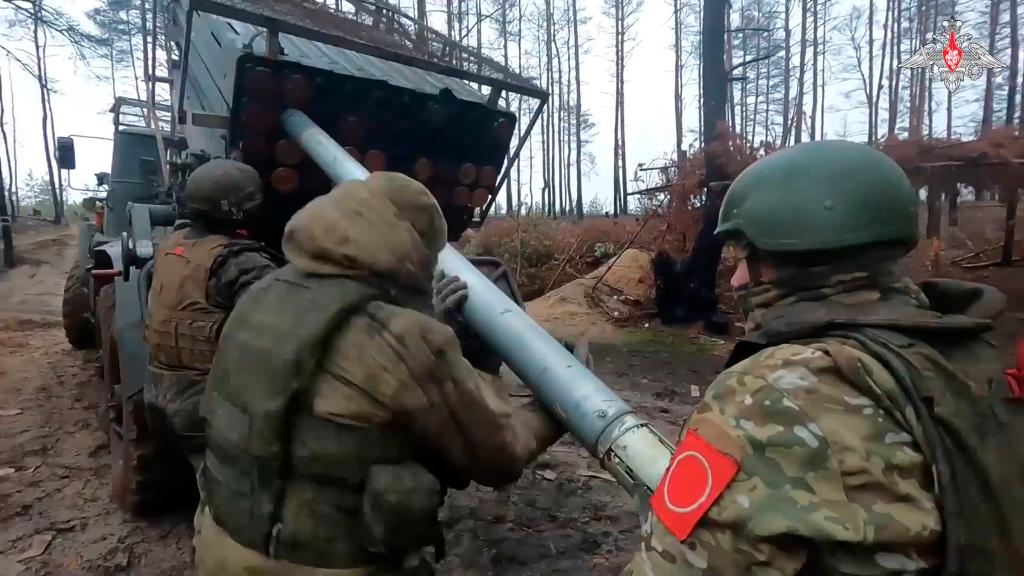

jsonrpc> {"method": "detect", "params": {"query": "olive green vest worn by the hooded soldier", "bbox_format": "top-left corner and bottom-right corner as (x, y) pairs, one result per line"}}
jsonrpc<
(201, 265), (442, 573)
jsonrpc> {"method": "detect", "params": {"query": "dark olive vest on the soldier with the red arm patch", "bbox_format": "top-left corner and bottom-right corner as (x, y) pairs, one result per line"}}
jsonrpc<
(730, 291), (1024, 576)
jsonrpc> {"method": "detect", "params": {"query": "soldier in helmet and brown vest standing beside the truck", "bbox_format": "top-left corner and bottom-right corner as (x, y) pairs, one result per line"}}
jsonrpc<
(145, 155), (282, 466)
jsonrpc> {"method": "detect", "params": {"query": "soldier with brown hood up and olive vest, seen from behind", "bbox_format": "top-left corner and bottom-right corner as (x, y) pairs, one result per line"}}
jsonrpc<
(196, 172), (577, 576)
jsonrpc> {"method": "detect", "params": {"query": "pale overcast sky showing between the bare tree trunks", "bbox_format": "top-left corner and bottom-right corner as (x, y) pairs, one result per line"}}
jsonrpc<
(0, 0), (1007, 204)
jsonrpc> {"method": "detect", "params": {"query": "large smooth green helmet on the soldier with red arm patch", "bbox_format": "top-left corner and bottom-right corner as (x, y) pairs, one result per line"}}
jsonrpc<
(715, 140), (919, 253)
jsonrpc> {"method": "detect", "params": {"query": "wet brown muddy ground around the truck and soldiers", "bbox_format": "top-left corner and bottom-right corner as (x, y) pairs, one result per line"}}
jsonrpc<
(0, 212), (1024, 576)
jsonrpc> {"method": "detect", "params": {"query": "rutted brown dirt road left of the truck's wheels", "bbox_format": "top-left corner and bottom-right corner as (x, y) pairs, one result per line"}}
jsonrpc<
(0, 227), (190, 576)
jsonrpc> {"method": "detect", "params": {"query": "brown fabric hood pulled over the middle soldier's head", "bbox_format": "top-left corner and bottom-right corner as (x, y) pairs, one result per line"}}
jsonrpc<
(282, 172), (447, 292)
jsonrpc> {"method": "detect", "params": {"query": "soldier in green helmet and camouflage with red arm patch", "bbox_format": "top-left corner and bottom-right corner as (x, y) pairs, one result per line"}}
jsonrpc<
(626, 141), (1024, 576)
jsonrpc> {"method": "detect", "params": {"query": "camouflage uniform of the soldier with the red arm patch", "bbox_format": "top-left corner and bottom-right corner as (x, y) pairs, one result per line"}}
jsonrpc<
(626, 142), (1024, 576)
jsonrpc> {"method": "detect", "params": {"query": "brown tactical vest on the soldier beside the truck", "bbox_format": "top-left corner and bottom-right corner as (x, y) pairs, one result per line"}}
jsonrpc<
(145, 230), (230, 374)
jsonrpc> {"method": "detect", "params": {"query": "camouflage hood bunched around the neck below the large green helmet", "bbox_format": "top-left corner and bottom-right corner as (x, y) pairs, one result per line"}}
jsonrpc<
(736, 265), (1006, 344)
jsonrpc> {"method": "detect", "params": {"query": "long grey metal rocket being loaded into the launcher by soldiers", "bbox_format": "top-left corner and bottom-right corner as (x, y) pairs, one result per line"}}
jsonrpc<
(282, 110), (673, 495)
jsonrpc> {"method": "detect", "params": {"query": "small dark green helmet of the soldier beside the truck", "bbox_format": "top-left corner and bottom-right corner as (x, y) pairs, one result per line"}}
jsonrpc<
(184, 159), (263, 222)
